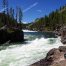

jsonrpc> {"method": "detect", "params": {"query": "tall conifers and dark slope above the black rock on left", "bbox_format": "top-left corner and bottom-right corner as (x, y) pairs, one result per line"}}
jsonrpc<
(0, 0), (23, 30)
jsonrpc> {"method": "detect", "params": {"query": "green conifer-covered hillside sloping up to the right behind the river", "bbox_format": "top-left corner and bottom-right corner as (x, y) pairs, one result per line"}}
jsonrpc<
(29, 5), (66, 31)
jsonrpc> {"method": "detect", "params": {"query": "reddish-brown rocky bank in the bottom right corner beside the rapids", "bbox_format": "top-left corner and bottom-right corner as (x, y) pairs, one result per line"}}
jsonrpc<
(30, 46), (66, 66)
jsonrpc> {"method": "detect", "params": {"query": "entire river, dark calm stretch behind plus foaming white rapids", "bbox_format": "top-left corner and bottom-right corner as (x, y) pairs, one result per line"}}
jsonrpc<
(0, 32), (62, 66)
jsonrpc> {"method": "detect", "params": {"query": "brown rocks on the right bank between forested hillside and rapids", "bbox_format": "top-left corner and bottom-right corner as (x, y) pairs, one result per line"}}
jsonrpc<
(54, 26), (66, 44)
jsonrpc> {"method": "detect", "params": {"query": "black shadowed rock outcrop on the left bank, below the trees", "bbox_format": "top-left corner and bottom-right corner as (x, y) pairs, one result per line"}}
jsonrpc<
(0, 26), (24, 45)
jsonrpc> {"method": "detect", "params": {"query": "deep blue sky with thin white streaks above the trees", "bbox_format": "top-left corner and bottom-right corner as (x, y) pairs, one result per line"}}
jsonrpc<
(0, 0), (66, 23)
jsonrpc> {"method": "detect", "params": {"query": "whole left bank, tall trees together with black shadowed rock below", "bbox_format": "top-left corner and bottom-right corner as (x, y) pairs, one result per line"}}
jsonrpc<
(0, 0), (24, 45)
